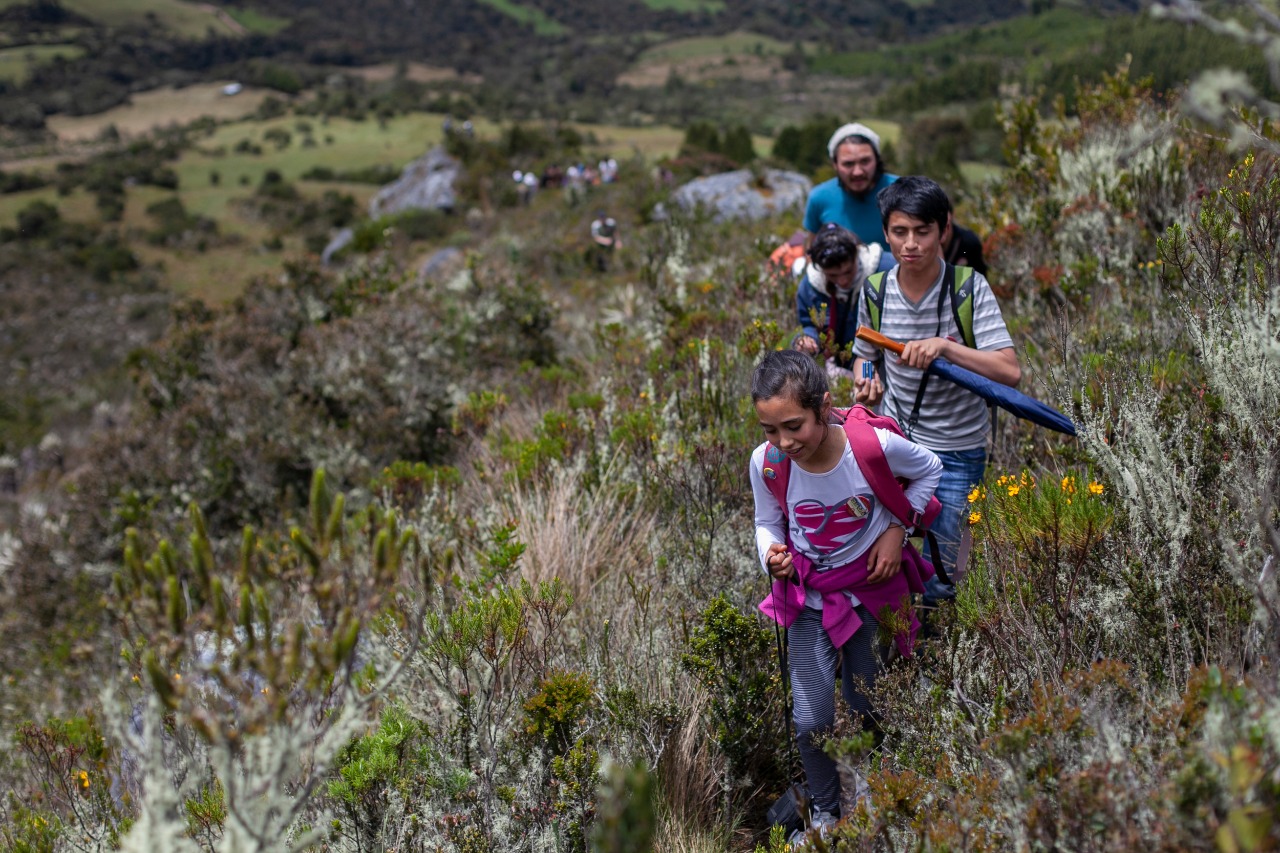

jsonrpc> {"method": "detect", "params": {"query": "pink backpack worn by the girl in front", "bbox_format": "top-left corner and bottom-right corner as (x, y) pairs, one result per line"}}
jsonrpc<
(763, 405), (951, 583)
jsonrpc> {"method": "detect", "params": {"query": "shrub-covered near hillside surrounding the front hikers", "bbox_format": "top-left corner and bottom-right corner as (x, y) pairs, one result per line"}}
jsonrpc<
(0, 56), (1280, 852)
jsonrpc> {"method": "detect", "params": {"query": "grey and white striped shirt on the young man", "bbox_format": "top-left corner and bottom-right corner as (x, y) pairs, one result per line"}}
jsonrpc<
(855, 264), (1014, 451)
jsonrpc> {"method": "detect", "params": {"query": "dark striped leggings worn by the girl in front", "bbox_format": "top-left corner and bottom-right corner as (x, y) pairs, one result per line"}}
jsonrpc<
(787, 606), (881, 815)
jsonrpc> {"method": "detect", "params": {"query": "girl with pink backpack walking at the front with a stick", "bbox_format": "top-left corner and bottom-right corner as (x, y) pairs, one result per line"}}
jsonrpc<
(750, 350), (942, 843)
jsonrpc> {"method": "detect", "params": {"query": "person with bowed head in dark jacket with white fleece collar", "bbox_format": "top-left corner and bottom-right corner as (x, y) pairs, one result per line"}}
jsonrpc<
(791, 223), (886, 379)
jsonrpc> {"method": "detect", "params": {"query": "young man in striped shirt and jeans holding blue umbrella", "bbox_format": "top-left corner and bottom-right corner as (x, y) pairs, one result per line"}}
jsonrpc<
(854, 175), (1021, 606)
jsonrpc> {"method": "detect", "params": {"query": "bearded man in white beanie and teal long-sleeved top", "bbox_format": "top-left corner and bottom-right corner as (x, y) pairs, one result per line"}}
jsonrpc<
(804, 123), (897, 248)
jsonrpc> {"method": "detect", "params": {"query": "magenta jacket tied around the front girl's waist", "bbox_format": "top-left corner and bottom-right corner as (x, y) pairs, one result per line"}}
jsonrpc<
(760, 544), (933, 657)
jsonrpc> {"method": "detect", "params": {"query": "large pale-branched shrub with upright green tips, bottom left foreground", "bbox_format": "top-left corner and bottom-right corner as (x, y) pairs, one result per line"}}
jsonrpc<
(108, 471), (424, 852)
